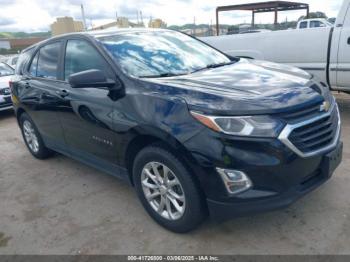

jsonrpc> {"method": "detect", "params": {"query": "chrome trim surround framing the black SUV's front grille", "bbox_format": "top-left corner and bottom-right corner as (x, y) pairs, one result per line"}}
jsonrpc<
(278, 102), (341, 158)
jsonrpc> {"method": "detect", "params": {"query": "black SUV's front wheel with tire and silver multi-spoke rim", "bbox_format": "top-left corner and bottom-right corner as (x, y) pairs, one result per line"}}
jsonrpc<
(133, 146), (206, 233)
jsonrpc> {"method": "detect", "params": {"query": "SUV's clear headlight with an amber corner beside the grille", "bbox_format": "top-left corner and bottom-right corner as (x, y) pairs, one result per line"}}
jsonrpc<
(191, 111), (284, 137)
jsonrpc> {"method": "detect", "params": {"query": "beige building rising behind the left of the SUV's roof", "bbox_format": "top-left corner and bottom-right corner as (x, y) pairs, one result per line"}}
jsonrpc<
(51, 16), (84, 36)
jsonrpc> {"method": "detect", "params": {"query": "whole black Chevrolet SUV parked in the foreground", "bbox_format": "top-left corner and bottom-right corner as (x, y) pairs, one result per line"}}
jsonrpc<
(11, 29), (342, 232)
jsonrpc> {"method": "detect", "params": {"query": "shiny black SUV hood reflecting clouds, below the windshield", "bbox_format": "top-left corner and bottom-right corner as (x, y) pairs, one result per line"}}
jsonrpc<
(143, 59), (324, 115)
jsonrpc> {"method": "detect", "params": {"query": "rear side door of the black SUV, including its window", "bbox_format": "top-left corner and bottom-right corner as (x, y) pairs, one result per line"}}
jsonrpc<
(19, 41), (65, 149)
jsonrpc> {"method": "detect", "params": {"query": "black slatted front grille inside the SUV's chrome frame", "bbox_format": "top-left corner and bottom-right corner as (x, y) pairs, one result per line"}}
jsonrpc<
(288, 107), (339, 154)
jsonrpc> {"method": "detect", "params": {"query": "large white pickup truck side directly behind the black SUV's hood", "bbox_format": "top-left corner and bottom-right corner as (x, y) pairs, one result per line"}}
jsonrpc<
(201, 0), (350, 92)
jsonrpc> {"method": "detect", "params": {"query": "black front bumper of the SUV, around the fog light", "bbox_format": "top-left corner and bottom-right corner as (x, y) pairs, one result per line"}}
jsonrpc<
(184, 114), (343, 221)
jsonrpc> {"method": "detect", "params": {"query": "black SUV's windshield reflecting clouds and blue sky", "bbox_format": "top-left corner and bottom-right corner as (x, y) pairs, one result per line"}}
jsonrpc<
(99, 31), (231, 77)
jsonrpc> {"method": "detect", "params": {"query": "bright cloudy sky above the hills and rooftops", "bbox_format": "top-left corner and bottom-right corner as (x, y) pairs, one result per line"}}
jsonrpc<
(0, 0), (343, 32)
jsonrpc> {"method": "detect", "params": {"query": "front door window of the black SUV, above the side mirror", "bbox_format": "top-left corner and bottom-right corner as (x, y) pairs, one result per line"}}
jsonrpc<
(64, 40), (113, 80)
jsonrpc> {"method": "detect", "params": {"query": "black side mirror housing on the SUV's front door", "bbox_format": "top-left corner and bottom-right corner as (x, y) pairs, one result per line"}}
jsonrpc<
(68, 69), (120, 89)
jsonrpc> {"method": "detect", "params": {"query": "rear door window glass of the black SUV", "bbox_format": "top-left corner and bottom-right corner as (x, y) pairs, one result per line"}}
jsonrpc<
(36, 42), (61, 79)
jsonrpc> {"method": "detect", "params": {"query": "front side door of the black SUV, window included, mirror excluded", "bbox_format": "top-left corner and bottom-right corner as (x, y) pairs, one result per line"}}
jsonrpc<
(56, 38), (117, 163)
